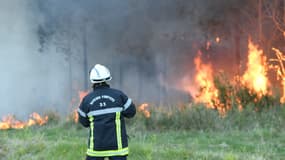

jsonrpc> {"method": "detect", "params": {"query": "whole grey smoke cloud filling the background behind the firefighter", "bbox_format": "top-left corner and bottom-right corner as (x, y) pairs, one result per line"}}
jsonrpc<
(0, 0), (253, 116)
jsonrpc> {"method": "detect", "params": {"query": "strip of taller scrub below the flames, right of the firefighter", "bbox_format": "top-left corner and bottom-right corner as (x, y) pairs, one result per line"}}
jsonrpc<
(131, 103), (285, 131)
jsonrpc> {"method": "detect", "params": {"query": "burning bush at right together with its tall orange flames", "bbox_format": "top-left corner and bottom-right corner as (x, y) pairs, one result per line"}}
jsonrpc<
(180, 39), (285, 115)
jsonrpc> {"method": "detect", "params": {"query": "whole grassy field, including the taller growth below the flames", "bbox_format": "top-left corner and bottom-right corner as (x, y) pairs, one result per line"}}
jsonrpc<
(0, 105), (285, 160)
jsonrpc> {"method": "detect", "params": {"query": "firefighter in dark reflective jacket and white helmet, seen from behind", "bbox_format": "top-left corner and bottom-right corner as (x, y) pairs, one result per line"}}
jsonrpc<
(78, 64), (136, 160)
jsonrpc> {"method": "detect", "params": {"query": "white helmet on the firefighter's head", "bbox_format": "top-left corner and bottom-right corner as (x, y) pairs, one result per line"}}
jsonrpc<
(89, 64), (112, 83)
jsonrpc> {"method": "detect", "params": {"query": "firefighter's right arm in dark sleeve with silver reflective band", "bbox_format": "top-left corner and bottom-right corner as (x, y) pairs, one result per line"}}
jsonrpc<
(122, 96), (136, 118)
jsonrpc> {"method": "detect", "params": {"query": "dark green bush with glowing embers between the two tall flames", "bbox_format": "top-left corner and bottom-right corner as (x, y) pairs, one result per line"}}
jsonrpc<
(214, 75), (280, 113)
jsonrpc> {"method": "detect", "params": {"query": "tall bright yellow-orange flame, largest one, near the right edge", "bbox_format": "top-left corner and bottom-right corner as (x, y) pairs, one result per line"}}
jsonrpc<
(241, 40), (269, 96)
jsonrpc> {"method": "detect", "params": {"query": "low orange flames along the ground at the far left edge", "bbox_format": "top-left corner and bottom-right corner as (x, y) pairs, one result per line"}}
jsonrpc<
(0, 112), (48, 130)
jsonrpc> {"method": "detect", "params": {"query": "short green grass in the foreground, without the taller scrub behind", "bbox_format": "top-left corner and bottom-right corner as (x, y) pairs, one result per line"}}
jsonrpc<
(0, 119), (285, 160)
